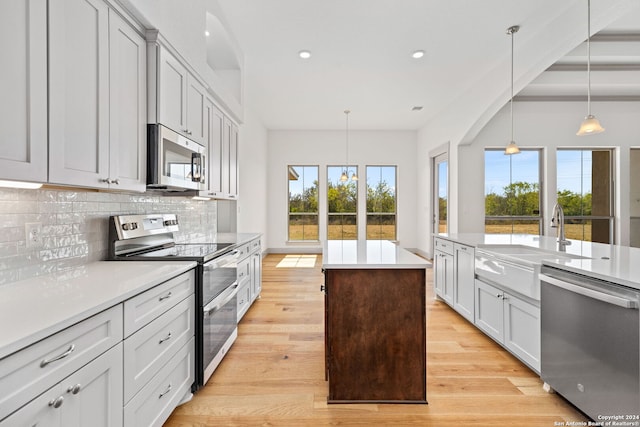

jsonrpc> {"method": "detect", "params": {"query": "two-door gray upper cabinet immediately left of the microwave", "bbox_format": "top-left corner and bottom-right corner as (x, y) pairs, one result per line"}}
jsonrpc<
(49, 0), (146, 191)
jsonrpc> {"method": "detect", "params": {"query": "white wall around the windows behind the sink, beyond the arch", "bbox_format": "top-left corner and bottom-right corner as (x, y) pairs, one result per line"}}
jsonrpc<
(458, 102), (640, 245)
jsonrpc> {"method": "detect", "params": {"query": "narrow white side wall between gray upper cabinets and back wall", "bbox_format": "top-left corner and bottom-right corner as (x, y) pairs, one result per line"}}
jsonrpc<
(237, 108), (269, 244)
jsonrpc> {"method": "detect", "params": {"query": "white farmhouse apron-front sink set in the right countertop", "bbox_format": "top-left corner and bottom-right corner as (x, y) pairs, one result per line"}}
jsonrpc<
(475, 245), (585, 301)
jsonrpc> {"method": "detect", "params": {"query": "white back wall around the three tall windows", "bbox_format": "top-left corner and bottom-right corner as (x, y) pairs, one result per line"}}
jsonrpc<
(267, 130), (418, 252)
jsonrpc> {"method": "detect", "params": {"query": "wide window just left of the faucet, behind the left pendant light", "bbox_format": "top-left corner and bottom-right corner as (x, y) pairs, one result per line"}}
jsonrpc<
(484, 149), (542, 234)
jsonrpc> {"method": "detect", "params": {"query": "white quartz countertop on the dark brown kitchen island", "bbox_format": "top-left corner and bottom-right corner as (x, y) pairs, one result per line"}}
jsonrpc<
(322, 240), (430, 269)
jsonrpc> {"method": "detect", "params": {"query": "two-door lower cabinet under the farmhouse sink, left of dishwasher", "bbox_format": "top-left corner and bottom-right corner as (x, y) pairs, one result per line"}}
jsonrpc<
(475, 280), (540, 373)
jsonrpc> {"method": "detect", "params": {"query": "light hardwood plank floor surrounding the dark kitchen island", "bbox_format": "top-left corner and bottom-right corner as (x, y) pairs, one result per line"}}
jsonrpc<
(165, 255), (586, 427)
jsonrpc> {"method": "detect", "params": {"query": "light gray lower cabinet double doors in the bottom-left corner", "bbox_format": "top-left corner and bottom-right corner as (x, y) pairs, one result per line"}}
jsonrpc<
(0, 344), (123, 427)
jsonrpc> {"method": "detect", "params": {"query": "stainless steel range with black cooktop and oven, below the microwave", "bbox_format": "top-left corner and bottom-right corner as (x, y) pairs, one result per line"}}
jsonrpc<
(109, 214), (238, 391)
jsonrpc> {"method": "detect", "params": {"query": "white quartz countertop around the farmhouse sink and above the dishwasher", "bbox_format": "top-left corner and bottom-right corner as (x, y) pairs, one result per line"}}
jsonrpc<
(435, 233), (640, 290)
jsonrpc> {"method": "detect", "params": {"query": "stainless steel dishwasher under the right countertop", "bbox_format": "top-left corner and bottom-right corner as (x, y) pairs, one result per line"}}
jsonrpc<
(540, 266), (640, 422)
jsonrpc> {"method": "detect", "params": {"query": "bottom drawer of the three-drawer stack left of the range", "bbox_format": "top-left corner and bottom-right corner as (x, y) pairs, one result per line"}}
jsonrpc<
(124, 339), (195, 427)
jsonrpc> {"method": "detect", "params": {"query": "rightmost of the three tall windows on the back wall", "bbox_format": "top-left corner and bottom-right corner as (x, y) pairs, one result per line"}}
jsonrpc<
(367, 166), (396, 240)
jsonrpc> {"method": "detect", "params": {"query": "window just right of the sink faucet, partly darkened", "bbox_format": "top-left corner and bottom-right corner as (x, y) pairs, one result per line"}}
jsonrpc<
(557, 149), (613, 243)
